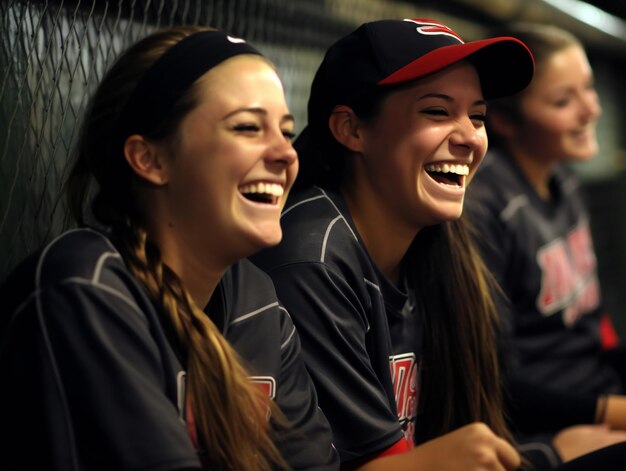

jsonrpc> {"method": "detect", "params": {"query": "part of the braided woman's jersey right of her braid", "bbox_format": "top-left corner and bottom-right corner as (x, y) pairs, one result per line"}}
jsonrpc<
(206, 259), (339, 471)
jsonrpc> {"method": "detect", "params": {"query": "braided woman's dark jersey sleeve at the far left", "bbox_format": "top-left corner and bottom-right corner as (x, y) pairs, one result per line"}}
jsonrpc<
(0, 280), (200, 470)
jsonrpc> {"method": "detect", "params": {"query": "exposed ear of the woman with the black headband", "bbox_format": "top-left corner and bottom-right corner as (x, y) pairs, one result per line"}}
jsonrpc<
(124, 134), (169, 186)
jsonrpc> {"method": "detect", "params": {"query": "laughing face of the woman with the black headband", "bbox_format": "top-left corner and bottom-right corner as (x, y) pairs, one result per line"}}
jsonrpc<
(160, 56), (298, 264)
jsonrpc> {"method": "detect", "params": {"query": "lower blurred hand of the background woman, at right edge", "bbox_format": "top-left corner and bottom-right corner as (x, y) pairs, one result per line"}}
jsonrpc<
(552, 424), (626, 461)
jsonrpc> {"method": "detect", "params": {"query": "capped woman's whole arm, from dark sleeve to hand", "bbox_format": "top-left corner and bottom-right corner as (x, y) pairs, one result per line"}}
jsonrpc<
(276, 265), (519, 471)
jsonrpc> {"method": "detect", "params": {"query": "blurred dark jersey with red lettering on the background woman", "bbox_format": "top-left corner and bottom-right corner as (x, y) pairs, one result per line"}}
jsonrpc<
(467, 152), (621, 428)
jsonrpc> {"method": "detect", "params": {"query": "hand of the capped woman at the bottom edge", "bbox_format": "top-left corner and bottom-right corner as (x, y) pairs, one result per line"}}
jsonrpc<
(413, 423), (520, 471)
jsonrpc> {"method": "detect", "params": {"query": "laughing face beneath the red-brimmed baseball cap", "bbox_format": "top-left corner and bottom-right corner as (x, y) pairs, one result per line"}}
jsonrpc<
(351, 62), (487, 232)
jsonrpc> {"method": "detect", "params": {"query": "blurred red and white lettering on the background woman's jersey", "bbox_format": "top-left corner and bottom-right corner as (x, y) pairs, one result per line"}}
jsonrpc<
(537, 223), (600, 327)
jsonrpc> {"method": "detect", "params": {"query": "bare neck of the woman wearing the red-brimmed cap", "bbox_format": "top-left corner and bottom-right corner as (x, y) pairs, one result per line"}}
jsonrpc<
(343, 186), (418, 286)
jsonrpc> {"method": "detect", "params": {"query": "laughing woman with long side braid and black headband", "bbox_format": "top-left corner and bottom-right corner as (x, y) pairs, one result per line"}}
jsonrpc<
(0, 27), (336, 470)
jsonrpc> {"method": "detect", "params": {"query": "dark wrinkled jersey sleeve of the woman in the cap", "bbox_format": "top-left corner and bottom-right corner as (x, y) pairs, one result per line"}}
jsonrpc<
(271, 263), (402, 464)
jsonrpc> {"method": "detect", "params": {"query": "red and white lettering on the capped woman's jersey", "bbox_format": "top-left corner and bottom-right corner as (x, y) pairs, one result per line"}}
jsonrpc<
(389, 353), (419, 448)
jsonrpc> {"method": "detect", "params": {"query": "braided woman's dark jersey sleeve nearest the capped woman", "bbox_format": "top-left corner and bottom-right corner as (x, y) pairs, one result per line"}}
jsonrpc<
(276, 306), (339, 471)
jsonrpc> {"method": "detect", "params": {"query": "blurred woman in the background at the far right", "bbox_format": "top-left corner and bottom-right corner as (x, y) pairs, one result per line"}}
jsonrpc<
(467, 24), (626, 463)
